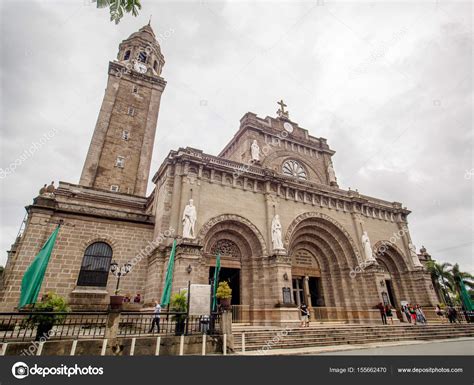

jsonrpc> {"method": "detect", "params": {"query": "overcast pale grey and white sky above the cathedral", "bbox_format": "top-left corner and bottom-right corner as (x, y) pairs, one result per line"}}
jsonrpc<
(0, 0), (474, 272)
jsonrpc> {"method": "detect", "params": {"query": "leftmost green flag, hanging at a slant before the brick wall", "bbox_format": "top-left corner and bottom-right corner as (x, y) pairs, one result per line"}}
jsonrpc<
(18, 226), (59, 308)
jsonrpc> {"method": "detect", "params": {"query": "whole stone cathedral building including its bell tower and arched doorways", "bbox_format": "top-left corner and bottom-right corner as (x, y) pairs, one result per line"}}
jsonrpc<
(0, 25), (437, 324)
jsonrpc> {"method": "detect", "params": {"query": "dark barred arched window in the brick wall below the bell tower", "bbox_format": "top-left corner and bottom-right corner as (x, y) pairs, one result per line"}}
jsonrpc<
(77, 242), (112, 287)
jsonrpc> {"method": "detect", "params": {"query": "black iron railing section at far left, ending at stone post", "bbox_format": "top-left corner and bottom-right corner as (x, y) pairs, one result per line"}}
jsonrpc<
(0, 312), (107, 342)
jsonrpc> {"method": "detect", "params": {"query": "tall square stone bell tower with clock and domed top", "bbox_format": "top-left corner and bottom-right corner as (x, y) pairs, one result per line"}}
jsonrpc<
(79, 24), (166, 196)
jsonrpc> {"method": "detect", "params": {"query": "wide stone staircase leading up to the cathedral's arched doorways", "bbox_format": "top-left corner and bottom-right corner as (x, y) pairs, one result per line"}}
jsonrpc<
(232, 324), (474, 352)
